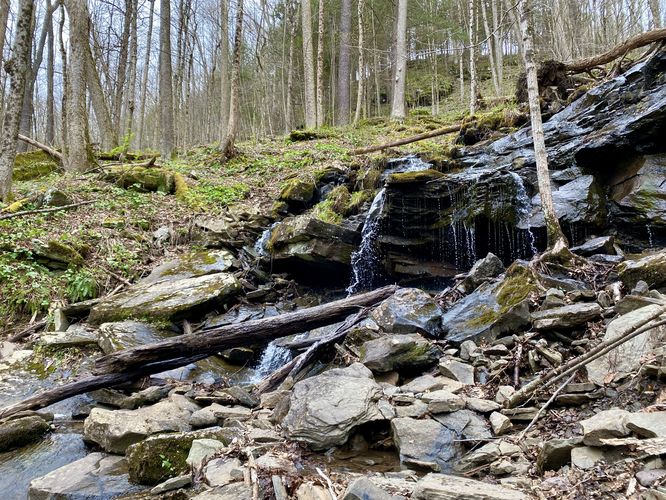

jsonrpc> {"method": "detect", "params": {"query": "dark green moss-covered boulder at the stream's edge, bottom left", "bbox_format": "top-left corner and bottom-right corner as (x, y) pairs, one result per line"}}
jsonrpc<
(126, 427), (238, 485)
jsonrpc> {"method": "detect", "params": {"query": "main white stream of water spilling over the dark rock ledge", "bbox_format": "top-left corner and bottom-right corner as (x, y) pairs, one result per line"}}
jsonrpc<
(347, 156), (432, 295)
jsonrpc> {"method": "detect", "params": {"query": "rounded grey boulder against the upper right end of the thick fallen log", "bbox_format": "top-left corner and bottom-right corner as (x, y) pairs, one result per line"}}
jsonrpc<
(371, 288), (442, 337)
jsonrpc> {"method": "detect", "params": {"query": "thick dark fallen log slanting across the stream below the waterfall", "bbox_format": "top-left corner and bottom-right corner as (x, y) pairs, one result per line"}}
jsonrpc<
(93, 286), (397, 375)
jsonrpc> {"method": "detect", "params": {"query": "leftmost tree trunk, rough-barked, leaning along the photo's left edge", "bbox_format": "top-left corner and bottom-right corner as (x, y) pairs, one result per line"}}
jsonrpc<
(0, 0), (33, 201)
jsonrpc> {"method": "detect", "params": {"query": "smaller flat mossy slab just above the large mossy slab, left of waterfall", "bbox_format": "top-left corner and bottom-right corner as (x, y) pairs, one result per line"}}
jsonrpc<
(141, 249), (239, 283)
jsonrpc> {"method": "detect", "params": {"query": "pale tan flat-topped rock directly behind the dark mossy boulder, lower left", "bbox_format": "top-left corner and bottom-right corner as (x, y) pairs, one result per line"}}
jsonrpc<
(83, 395), (199, 453)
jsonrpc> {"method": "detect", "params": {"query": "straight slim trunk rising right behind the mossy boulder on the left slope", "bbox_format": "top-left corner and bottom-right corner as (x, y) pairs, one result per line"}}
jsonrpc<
(159, 0), (175, 160)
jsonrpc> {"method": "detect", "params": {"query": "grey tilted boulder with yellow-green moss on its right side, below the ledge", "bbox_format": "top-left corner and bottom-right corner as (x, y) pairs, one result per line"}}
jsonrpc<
(442, 264), (536, 343)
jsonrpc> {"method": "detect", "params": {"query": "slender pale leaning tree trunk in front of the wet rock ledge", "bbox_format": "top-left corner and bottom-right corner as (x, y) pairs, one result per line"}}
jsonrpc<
(519, 0), (568, 253)
